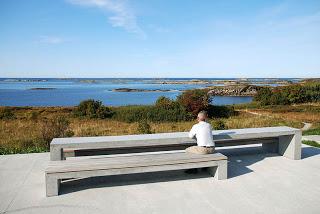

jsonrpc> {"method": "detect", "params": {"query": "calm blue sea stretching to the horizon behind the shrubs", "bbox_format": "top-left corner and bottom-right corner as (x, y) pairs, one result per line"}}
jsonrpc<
(0, 78), (298, 106)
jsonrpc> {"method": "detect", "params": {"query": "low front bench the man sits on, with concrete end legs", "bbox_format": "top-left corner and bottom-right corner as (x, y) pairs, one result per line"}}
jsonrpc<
(45, 151), (227, 196)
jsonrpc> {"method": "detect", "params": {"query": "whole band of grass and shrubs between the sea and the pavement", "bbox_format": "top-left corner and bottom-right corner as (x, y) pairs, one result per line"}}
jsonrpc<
(0, 81), (320, 154)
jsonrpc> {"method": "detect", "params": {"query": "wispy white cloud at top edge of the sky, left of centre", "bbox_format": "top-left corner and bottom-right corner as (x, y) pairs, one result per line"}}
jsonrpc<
(67, 0), (146, 38)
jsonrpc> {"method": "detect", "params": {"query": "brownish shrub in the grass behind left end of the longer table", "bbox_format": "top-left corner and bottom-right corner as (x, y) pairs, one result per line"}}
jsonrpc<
(41, 116), (74, 148)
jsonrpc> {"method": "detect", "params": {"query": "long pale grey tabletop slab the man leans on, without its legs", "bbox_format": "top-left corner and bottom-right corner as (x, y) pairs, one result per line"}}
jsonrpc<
(51, 126), (298, 148)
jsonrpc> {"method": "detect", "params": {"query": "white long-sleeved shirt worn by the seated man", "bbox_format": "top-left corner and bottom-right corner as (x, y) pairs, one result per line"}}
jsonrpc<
(189, 121), (214, 146)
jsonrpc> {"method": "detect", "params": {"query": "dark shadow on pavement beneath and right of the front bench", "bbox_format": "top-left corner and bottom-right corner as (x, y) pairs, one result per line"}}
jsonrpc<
(59, 146), (278, 194)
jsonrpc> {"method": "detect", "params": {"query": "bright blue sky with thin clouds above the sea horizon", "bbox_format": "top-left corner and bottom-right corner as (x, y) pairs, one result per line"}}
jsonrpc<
(0, 0), (320, 78)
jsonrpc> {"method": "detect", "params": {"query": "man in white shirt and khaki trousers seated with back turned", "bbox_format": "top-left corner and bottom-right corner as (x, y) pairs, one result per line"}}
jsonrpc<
(186, 111), (215, 154)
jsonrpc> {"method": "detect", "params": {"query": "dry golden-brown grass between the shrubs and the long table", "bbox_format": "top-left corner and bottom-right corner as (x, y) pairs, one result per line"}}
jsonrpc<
(0, 105), (320, 154)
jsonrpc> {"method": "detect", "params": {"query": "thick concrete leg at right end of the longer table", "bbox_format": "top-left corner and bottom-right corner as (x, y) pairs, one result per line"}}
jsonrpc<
(279, 131), (301, 160)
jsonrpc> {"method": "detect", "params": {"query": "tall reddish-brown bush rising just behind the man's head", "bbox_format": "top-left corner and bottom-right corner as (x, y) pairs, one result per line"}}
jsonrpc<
(177, 89), (212, 117)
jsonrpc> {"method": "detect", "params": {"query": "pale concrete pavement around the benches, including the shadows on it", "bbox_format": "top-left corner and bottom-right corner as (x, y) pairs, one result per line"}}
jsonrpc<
(0, 145), (320, 214)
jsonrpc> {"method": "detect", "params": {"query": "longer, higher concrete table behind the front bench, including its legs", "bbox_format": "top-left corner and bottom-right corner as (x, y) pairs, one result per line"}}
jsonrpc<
(50, 126), (301, 161)
